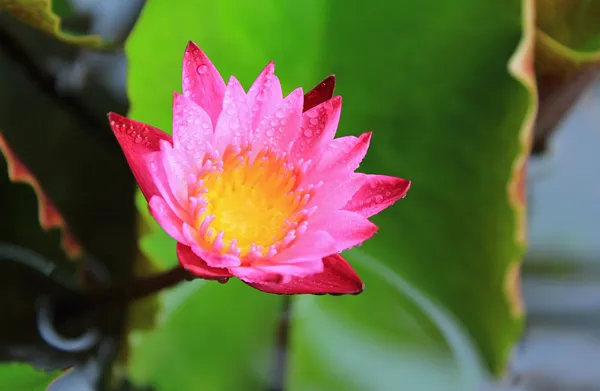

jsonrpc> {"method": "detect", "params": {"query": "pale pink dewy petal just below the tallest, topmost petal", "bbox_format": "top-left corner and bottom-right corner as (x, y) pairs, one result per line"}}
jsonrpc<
(173, 93), (214, 163)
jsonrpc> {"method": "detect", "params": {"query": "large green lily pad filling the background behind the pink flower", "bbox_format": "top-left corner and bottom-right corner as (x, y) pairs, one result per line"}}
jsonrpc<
(126, 0), (535, 390)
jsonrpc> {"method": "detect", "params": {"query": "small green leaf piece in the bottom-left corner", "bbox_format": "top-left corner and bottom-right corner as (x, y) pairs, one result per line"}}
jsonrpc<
(0, 364), (58, 391)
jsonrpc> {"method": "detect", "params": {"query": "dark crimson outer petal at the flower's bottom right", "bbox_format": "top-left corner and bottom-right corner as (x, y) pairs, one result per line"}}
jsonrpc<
(246, 254), (364, 295)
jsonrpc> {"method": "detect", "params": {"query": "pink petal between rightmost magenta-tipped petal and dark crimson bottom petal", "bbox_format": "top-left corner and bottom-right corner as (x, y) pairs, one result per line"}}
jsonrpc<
(311, 210), (377, 252)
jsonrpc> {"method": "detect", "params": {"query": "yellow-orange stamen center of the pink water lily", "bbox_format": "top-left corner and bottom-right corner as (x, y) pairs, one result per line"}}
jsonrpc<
(195, 148), (314, 259)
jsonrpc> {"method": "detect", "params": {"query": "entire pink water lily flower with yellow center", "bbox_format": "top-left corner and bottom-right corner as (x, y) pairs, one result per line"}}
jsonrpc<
(109, 42), (410, 294)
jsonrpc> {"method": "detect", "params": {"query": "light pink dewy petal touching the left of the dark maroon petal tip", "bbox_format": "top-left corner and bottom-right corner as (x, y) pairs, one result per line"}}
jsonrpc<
(252, 88), (304, 153)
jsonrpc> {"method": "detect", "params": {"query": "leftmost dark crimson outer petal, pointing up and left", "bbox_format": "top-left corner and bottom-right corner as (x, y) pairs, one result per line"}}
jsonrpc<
(108, 113), (171, 200)
